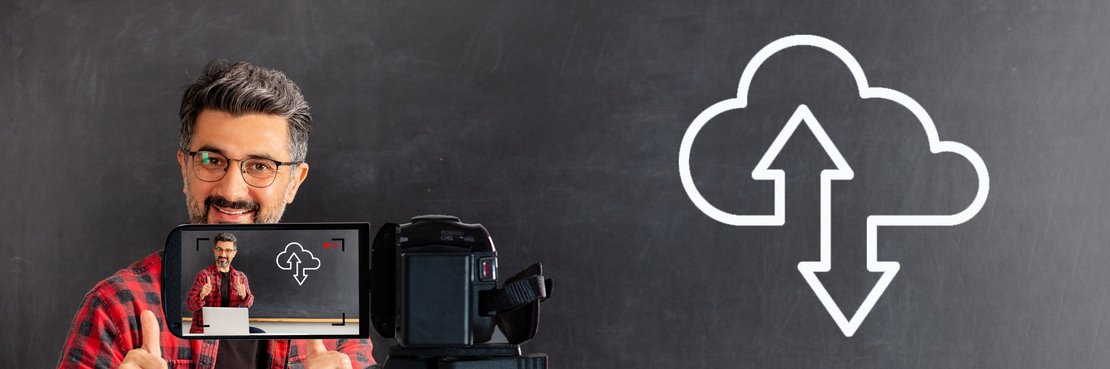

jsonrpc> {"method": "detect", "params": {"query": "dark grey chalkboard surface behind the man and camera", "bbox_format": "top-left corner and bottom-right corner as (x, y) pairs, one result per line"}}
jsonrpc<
(0, 0), (1110, 369)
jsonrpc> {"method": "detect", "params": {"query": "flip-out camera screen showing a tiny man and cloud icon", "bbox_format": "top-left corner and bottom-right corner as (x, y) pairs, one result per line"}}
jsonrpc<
(162, 223), (370, 339)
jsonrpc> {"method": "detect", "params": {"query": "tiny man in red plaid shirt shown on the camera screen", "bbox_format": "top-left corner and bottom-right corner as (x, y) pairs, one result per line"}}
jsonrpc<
(186, 232), (254, 335)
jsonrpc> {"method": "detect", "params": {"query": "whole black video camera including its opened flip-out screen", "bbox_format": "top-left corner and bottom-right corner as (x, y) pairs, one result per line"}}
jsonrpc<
(162, 216), (552, 369)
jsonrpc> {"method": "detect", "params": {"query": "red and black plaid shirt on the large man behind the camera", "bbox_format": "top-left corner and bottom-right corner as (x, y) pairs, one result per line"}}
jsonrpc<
(58, 251), (374, 369)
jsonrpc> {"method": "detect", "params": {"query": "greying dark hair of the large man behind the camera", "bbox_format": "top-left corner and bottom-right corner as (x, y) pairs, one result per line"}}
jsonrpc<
(179, 59), (312, 162)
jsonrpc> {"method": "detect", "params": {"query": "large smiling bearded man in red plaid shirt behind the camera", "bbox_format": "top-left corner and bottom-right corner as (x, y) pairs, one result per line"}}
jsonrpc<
(58, 61), (374, 369)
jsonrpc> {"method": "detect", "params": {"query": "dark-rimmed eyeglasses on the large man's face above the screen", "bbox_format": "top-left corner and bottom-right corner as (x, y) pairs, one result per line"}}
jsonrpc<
(182, 150), (303, 188)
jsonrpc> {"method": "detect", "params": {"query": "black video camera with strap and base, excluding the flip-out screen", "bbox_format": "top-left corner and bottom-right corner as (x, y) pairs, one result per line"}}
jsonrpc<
(370, 216), (552, 369)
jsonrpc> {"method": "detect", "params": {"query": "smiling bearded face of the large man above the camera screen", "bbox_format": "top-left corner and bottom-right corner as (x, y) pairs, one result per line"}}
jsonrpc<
(178, 109), (309, 223)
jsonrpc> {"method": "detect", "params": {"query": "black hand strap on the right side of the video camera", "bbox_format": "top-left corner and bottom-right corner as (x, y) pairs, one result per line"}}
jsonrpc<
(478, 262), (553, 345)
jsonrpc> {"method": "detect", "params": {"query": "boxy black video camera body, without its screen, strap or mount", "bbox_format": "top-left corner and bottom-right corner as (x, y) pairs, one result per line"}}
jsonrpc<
(371, 216), (497, 348)
